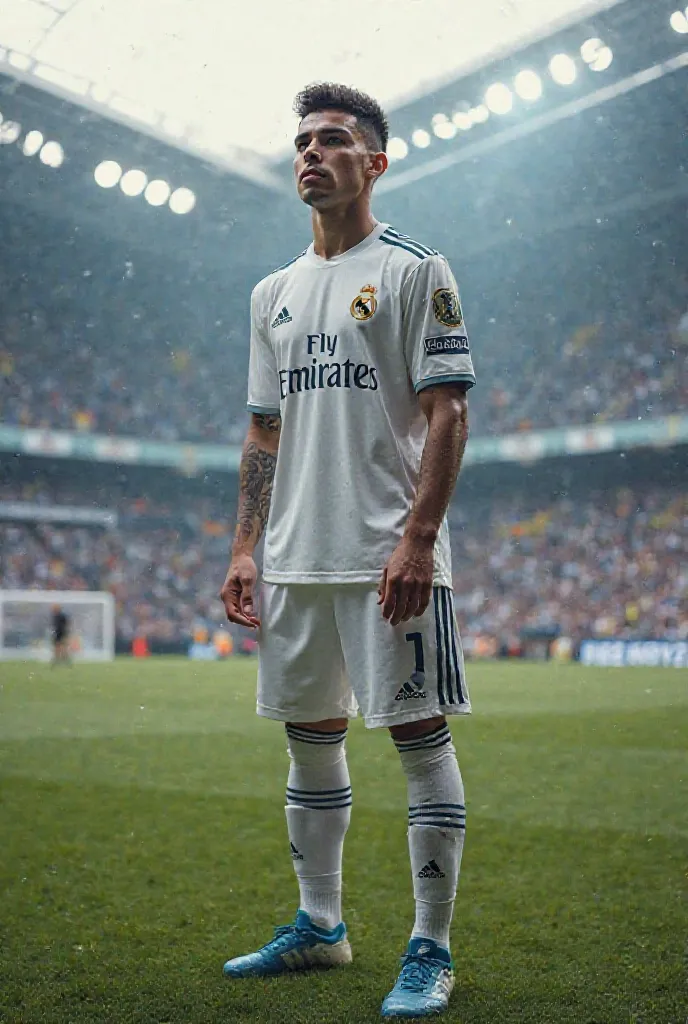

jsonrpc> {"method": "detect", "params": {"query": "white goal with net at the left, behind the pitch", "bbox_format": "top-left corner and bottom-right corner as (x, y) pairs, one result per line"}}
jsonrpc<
(0, 590), (115, 662)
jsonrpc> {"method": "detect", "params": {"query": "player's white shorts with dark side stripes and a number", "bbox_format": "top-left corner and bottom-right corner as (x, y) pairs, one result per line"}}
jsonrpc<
(257, 584), (471, 729)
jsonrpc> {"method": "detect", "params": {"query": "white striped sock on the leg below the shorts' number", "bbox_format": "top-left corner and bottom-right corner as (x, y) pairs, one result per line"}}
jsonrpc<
(395, 723), (466, 949)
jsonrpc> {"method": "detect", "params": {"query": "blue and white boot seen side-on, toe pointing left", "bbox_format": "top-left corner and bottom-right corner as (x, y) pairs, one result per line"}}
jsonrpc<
(223, 910), (351, 978)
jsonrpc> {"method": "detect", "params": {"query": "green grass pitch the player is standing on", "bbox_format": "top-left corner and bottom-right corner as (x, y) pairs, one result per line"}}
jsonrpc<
(0, 659), (688, 1024)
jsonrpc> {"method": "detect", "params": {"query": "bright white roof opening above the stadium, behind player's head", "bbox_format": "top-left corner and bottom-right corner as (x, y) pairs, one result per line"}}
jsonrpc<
(0, 0), (619, 187)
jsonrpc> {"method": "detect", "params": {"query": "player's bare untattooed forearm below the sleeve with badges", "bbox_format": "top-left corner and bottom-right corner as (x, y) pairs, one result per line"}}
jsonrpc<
(404, 395), (468, 543)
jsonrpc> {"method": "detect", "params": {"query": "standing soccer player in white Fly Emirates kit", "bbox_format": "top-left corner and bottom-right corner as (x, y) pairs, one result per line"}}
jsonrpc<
(221, 84), (475, 1017)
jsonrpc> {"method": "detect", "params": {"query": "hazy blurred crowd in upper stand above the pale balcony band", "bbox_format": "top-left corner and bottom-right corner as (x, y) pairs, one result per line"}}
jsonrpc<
(0, 256), (688, 443)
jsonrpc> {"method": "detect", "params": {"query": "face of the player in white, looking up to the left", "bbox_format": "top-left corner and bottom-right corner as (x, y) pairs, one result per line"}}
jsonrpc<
(294, 111), (384, 210)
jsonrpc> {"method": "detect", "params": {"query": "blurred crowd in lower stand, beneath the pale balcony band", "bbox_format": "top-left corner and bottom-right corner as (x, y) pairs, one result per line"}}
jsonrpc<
(0, 488), (688, 650)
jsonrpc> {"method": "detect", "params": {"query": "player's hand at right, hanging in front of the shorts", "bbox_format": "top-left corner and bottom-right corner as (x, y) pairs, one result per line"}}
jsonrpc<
(378, 535), (435, 626)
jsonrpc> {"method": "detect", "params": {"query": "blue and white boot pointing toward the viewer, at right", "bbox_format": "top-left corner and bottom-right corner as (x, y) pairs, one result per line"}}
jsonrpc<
(382, 938), (454, 1017)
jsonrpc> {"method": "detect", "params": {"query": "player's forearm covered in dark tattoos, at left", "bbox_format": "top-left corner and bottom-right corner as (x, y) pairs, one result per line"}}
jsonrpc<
(232, 417), (281, 555)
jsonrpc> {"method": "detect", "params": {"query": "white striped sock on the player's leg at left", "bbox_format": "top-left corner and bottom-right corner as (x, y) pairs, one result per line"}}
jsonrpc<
(286, 725), (351, 930)
